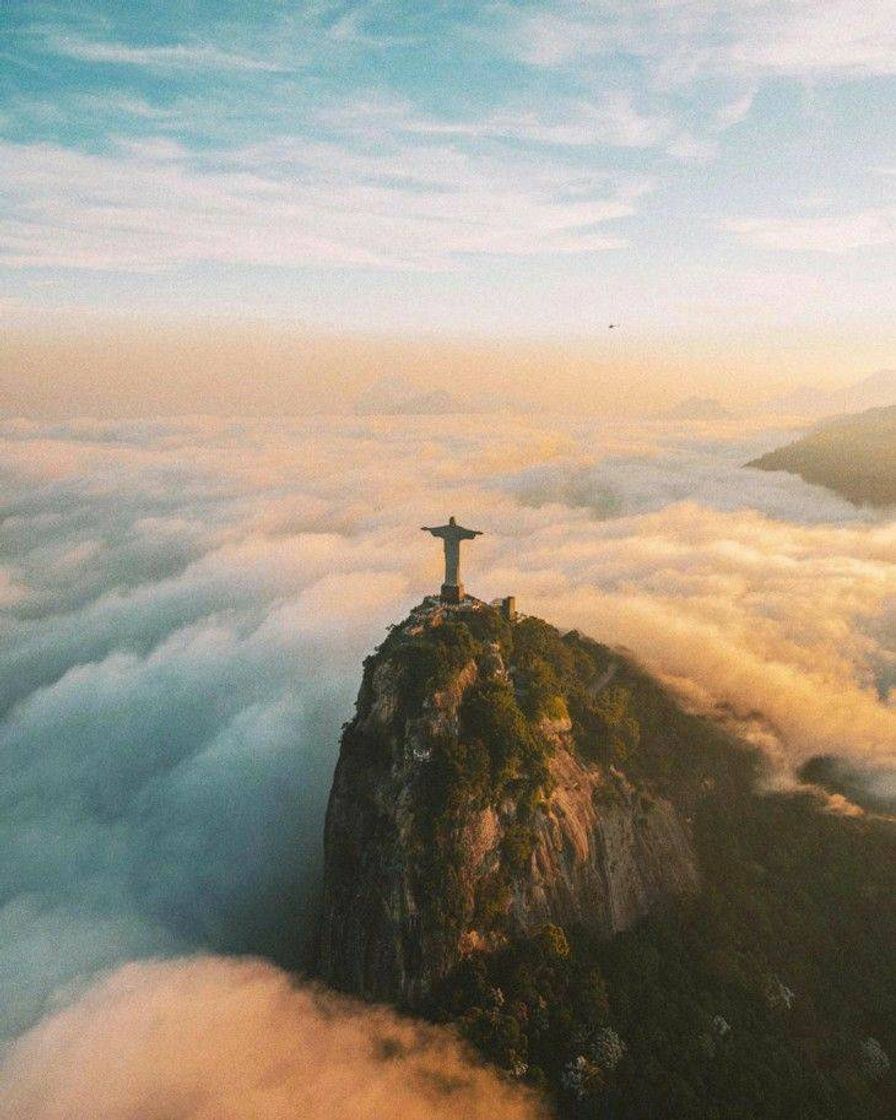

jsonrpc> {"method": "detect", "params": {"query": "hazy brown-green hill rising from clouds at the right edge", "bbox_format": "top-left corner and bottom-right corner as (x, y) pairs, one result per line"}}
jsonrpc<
(747, 405), (896, 506)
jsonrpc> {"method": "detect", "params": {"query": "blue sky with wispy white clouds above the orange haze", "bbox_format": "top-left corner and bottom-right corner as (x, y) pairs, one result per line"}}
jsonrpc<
(0, 0), (896, 345)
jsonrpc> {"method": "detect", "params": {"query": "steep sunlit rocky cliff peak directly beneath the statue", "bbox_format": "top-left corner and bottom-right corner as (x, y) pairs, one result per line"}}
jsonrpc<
(319, 600), (712, 1007)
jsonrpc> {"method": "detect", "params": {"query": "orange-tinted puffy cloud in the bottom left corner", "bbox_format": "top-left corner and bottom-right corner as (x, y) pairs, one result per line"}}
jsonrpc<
(0, 958), (542, 1120)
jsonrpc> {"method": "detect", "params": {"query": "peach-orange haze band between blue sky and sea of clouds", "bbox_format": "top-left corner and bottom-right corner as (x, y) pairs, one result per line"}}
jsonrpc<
(0, 320), (896, 419)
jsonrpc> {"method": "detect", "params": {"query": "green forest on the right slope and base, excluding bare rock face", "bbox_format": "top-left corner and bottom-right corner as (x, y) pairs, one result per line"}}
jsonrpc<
(407, 615), (896, 1120)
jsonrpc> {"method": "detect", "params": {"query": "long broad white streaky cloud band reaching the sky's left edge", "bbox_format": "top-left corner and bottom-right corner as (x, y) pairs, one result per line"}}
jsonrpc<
(0, 130), (634, 272)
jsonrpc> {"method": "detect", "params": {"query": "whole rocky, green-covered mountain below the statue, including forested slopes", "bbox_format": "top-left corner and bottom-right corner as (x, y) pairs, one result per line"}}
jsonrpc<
(325, 608), (896, 1120)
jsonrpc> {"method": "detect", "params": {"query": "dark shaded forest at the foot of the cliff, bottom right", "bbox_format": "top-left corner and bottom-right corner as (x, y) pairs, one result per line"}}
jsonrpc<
(430, 790), (896, 1120)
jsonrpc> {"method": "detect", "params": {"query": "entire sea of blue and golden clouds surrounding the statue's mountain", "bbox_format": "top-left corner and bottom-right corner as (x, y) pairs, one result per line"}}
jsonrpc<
(0, 416), (896, 1120)
